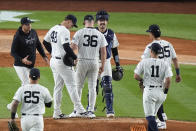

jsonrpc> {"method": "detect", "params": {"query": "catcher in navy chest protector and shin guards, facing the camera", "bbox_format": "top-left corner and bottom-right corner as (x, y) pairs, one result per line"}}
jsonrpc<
(96, 10), (122, 117)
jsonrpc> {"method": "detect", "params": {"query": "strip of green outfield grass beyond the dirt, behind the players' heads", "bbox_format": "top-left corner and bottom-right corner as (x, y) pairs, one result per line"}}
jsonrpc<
(0, 11), (196, 40)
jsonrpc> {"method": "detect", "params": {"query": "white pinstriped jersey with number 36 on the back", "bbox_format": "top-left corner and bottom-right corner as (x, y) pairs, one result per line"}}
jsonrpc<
(72, 28), (107, 60)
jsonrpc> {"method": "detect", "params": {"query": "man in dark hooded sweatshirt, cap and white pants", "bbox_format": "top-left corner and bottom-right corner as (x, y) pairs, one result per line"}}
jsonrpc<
(7, 17), (49, 117)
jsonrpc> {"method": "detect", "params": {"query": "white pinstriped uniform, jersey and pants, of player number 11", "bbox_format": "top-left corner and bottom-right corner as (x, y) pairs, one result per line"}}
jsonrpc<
(134, 58), (173, 117)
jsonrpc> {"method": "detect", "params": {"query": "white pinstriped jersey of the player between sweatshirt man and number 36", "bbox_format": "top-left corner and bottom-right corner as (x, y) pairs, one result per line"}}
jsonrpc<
(44, 25), (70, 57)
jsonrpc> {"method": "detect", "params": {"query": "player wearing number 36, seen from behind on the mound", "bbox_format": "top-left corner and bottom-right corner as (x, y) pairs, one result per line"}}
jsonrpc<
(70, 15), (107, 118)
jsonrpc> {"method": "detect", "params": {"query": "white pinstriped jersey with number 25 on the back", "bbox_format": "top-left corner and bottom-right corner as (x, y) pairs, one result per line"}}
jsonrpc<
(13, 84), (52, 114)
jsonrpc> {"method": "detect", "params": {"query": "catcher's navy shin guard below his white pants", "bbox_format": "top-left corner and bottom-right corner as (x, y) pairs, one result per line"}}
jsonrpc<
(101, 76), (114, 114)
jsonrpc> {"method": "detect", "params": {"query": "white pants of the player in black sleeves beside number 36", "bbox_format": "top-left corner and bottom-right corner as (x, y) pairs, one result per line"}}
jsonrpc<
(50, 57), (85, 115)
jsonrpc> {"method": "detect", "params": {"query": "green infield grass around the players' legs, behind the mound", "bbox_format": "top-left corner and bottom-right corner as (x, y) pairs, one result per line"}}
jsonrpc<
(0, 65), (196, 121)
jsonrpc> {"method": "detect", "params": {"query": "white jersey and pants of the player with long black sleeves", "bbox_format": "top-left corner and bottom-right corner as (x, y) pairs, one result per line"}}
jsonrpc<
(44, 25), (85, 117)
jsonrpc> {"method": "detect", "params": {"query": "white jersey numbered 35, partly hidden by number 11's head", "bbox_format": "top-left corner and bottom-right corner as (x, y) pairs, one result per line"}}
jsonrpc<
(141, 40), (176, 66)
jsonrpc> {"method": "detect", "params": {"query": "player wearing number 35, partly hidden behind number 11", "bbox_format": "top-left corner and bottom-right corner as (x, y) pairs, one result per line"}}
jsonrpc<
(142, 24), (181, 129)
